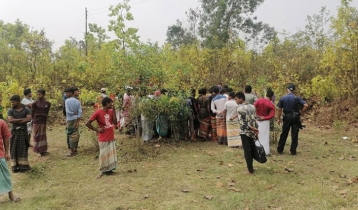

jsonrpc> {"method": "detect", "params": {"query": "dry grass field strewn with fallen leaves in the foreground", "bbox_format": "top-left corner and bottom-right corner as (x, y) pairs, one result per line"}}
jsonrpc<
(0, 126), (358, 210)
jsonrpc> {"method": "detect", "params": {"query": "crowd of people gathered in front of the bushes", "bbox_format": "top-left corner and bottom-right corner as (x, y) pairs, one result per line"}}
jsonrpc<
(0, 84), (308, 202)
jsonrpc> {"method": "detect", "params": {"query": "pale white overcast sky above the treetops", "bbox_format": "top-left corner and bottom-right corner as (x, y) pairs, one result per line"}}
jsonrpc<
(0, 0), (358, 49)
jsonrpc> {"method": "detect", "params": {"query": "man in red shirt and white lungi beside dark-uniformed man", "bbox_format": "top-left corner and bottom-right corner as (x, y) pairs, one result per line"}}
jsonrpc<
(254, 90), (275, 155)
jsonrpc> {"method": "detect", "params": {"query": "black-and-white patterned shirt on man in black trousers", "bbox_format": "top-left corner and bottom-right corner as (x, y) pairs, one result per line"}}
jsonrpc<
(237, 102), (258, 138)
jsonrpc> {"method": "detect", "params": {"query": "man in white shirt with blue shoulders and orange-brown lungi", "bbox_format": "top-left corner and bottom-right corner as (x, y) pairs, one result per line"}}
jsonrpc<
(211, 87), (227, 145)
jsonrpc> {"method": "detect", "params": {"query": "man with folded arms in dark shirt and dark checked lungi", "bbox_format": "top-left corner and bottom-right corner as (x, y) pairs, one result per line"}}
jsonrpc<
(7, 95), (31, 173)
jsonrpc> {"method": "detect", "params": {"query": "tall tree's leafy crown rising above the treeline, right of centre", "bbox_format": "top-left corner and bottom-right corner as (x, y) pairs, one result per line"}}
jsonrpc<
(199, 0), (276, 49)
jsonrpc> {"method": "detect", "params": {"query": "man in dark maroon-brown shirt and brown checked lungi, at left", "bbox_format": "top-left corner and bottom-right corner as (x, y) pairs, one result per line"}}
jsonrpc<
(31, 89), (51, 156)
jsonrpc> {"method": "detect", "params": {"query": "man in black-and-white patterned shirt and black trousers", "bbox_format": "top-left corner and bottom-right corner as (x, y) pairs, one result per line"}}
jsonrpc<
(234, 92), (258, 174)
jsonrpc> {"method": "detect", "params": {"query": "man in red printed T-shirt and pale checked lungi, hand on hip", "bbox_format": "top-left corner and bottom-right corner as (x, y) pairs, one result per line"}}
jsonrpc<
(86, 97), (117, 178)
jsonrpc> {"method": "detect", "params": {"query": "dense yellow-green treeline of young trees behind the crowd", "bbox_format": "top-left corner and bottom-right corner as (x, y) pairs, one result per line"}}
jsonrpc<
(0, 0), (358, 110)
